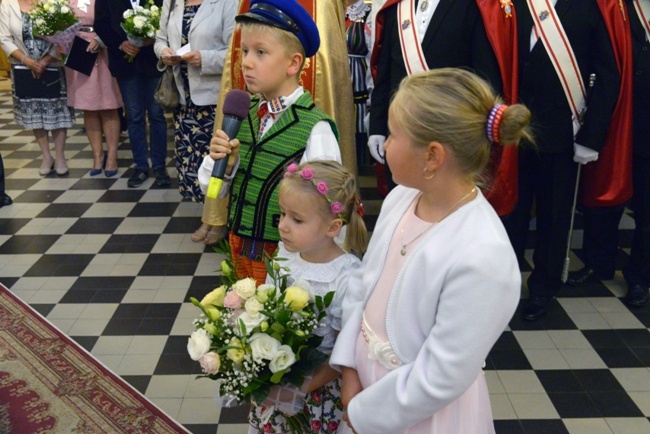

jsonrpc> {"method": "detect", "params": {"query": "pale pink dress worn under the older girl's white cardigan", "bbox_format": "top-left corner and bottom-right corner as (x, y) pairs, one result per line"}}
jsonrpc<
(346, 200), (495, 434)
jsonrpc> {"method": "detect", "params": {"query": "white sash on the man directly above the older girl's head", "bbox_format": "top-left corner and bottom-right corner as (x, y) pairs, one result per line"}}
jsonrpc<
(397, 0), (429, 75)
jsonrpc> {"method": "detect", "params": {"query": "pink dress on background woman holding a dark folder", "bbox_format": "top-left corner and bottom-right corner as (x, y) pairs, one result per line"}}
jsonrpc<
(65, 0), (124, 110)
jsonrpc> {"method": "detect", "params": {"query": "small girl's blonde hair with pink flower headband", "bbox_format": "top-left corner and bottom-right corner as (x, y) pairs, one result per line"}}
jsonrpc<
(280, 161), (368, 256)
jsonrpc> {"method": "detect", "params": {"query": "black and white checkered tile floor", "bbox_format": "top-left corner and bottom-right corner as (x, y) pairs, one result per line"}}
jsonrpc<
(0, 78), (650, 434)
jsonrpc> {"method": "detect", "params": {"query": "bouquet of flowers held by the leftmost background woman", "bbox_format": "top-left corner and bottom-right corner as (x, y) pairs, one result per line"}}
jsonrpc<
(29, 0), (81, 53)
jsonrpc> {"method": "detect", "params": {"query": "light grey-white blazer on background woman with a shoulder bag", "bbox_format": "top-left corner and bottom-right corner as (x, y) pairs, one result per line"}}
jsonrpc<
(154, 0), (238, 105)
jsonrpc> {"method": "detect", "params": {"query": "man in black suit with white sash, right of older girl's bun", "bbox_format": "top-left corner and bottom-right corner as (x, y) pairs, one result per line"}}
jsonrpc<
(504, 0), (621, 320)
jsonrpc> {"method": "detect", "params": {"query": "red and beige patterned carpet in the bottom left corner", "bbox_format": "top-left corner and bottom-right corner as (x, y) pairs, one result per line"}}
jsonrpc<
(0, 284), (189, 434)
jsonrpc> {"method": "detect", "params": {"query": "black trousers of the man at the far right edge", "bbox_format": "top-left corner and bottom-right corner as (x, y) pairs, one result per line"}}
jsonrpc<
(583, 155), (650, 286)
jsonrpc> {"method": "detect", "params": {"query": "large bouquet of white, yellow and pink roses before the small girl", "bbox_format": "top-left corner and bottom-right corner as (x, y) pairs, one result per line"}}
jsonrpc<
(187, 242), (334, 433)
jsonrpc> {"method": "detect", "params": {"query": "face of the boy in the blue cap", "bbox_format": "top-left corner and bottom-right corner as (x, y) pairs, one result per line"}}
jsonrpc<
(241, 28), (299, 100)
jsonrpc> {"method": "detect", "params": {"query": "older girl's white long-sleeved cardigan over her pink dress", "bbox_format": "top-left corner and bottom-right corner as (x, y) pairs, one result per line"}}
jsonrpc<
(330, 186), (521, 433)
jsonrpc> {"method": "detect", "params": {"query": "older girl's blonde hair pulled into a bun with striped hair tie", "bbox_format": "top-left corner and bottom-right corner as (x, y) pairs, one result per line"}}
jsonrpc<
(390, 68), (533, 185)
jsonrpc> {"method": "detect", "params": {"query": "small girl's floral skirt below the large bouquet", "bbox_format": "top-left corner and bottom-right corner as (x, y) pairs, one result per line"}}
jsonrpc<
(248, 377), (343, 434)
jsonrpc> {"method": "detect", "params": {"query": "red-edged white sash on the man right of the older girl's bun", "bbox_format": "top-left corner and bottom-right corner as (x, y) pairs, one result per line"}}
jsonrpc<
(528, 0), (586, 137)
